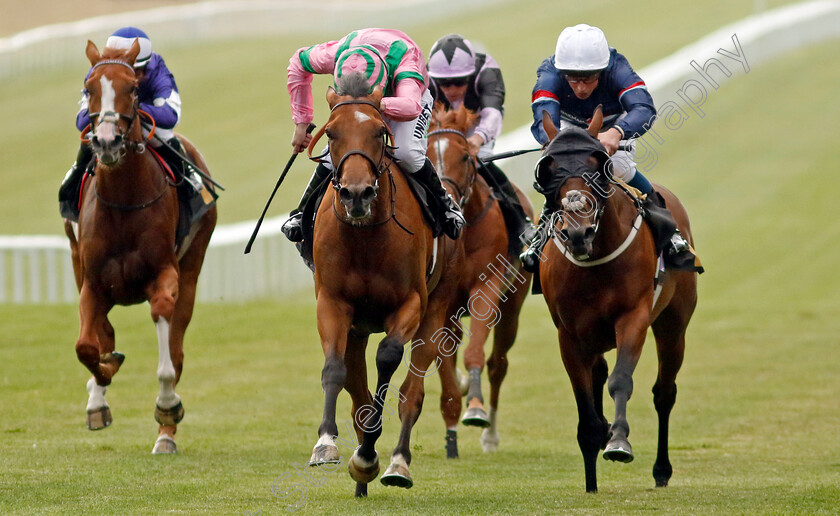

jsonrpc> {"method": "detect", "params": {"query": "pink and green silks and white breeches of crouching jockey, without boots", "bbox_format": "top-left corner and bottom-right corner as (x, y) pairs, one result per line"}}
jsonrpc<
(287, 29), (432, 172)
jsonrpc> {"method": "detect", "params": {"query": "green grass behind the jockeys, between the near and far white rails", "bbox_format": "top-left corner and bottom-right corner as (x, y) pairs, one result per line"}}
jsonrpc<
(0, 0), (800, 234)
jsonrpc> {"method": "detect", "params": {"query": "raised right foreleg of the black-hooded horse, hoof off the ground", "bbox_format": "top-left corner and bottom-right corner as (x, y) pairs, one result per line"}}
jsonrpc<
(604, 308), (650, 462)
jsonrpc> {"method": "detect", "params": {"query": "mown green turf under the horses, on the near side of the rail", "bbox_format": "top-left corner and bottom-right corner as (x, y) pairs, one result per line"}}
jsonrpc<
(0, 34), (840, 514)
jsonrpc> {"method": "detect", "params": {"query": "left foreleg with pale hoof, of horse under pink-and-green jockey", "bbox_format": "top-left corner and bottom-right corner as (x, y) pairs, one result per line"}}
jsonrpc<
(309, 291), (353, 466)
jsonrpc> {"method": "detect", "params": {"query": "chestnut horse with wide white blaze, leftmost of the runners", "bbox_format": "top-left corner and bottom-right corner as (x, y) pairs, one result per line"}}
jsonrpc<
(64, 41), (216, 453)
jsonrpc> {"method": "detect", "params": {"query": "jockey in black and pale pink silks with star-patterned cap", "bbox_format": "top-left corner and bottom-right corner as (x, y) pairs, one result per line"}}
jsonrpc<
(428, 34), (533, 246)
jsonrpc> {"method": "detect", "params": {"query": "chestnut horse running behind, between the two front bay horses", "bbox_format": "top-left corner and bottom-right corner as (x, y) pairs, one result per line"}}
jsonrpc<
(427, 103), (533, 458)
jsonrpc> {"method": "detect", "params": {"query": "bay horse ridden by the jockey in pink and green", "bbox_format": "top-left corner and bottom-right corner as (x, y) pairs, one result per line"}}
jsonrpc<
(308, 74), (463, 497)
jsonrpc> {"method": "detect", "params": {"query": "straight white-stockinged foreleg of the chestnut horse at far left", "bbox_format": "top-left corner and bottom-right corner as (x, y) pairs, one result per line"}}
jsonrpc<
(147, 266), (184, 453)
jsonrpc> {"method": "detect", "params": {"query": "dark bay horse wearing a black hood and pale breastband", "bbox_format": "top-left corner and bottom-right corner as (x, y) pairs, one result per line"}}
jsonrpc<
(536, 110), (697, 492)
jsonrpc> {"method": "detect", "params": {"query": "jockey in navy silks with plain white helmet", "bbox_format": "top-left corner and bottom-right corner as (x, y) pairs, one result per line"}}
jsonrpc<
(521, 24), (694, 272)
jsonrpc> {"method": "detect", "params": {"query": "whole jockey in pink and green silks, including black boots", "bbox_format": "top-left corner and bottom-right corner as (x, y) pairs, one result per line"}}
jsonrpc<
(282, 29), (464, 242)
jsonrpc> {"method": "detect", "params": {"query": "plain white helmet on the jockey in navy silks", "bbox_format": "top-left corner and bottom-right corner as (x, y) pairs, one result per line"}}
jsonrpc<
(554, 23), (610, 72)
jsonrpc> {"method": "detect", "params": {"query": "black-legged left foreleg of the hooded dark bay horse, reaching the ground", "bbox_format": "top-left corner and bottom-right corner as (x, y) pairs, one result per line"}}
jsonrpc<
(559, 326), (608, 492)
